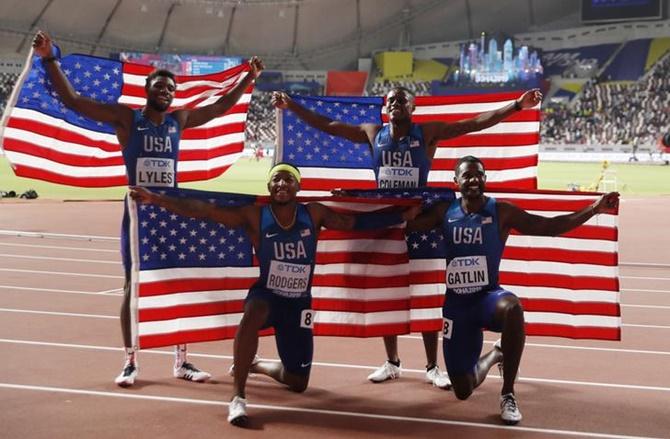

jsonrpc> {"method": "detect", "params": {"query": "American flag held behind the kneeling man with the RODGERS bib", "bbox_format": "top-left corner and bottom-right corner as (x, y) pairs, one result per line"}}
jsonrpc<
(128, 189), (418, 348)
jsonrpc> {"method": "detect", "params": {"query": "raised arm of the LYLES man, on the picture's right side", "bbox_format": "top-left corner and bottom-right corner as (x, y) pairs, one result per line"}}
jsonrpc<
(174, 56), (264, 128)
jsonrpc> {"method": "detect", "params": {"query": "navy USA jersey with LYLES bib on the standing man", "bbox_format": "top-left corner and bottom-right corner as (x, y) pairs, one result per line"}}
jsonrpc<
(122, 110), (181, 187)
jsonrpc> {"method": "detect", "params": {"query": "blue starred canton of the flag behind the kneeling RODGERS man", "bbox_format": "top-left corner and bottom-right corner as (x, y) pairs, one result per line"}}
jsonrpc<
(137, 189), (256, 270)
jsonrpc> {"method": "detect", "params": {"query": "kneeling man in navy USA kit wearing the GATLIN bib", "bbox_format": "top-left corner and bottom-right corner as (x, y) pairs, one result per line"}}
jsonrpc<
(407, 156), (619, 424)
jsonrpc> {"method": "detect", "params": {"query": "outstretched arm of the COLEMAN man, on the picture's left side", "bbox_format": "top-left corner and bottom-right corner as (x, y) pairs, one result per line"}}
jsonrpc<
(272, 91), (379, 144)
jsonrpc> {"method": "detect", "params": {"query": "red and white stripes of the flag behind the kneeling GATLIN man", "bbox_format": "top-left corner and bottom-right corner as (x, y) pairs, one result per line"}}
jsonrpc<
(410, 191), (621, 340)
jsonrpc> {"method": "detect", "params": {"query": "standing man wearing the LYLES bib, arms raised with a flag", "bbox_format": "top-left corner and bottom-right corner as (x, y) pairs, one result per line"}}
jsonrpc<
(33, 31), (263, 387)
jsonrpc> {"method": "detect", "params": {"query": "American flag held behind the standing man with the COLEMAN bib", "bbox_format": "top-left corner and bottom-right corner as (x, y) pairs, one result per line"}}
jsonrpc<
(276, 93), (540, 193)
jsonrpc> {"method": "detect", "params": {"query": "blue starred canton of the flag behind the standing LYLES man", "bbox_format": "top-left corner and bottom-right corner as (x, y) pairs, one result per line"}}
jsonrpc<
(16, 55), (123, 134)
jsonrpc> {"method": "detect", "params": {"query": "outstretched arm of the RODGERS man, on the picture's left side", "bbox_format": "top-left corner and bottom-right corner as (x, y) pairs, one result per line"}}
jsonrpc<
(130, 186), (258, 227)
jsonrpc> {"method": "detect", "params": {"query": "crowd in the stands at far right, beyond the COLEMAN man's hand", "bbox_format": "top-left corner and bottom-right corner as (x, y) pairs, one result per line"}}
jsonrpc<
(541, 57), (670, 146)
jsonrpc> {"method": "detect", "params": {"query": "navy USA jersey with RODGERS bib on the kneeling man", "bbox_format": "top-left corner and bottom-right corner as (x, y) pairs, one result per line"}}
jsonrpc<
(252, 204), (316, 298)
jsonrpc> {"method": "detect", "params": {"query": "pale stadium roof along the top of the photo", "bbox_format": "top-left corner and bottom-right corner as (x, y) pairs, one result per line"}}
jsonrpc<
(0, 0), (580, 70)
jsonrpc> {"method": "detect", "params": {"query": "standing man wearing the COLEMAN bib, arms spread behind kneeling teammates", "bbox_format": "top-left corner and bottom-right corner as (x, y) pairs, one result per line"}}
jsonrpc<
(272, 87), (542, 388)
